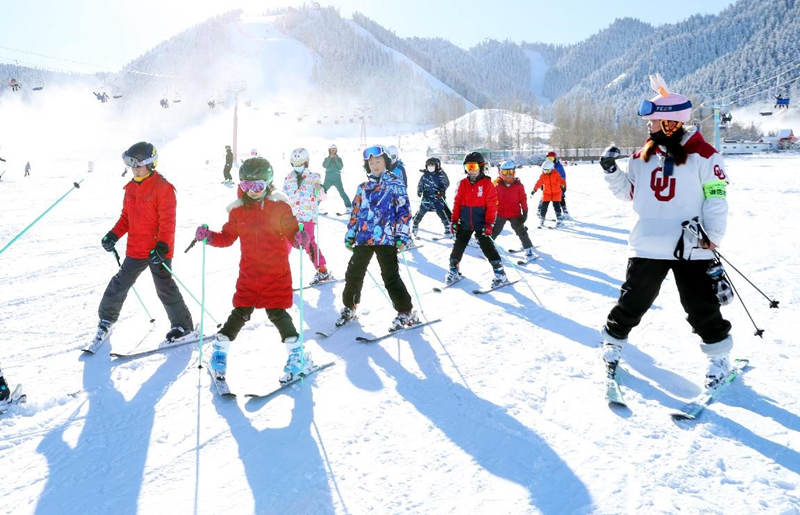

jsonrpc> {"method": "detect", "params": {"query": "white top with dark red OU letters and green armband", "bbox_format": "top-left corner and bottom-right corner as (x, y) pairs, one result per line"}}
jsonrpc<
(605, 128), (728, 260)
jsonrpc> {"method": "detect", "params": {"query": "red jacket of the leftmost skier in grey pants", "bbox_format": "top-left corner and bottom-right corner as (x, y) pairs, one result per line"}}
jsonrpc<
(111, 171), (176, 259)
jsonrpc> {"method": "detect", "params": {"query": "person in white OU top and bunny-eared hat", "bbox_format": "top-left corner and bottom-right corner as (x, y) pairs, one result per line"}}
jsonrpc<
(600, 74), (733, 387)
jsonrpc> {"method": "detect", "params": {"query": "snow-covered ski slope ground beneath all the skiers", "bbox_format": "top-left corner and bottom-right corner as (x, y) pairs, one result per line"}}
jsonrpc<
(0, 146), (800, 514)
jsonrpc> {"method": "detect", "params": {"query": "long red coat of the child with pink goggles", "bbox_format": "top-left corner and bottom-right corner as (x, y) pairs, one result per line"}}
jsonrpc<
(209, 193), (297, 309)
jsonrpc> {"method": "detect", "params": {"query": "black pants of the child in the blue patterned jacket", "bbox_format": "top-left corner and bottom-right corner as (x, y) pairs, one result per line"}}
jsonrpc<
(342, 245), (413, 312)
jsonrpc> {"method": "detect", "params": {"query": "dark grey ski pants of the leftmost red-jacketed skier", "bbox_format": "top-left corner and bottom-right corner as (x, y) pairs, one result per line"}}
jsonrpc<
(97, 257), (194, 330)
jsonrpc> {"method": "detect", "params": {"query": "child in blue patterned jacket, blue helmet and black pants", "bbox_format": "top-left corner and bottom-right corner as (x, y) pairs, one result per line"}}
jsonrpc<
(336, 145), (419, 331)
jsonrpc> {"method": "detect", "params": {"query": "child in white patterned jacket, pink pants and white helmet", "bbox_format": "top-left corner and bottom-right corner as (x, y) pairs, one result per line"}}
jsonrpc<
(283, 148), (332, 284)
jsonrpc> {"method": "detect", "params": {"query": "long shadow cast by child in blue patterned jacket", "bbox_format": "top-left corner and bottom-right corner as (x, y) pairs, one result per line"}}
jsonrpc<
(368, 335), (592, 513)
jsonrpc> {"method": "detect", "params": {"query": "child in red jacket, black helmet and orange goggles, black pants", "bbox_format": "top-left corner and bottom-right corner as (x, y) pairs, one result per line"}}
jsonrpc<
(445, 152), (508, 287)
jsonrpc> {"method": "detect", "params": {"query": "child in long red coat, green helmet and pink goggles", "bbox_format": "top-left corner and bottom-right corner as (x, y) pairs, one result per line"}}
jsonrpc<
(195, 157), (313, 383)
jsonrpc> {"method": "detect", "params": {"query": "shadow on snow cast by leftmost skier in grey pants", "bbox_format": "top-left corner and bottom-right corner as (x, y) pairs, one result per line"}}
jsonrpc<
(36, 349), (192, 514)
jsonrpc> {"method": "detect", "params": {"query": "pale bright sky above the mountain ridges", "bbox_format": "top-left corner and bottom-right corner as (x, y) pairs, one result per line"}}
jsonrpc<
(0, 0), (732, 71)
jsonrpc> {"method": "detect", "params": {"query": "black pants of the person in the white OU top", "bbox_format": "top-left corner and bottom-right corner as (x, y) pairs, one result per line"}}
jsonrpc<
(606, 258), (731, 343)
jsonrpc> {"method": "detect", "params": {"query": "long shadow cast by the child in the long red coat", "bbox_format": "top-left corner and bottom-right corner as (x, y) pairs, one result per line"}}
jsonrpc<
(214, 384), (335, 514)
